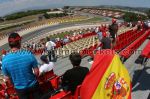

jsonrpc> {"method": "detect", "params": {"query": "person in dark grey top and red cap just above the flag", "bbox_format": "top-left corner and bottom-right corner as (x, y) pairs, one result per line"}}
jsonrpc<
(101, 32), (111, 49)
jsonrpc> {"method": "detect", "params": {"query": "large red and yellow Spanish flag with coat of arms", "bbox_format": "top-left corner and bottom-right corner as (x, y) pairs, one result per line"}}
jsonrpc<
(80, 50), (131, 99)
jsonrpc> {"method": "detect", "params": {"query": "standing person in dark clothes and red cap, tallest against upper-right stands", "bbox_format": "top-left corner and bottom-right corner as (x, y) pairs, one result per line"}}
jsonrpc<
(109, 18), (118, 44)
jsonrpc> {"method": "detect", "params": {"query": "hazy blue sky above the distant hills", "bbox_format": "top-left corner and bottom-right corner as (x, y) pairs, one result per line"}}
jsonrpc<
(0, 0), (150, 16)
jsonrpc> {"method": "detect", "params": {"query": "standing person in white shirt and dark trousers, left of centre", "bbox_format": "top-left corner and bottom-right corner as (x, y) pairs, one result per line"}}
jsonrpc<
(46, 38), (56, 61)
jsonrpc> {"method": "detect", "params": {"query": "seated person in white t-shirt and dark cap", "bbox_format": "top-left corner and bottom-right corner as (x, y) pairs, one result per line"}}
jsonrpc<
(39, 55), (54, 75)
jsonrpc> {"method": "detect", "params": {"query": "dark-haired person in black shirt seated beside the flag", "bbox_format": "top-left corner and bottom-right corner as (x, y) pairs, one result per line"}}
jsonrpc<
(62, 53), (89, 94)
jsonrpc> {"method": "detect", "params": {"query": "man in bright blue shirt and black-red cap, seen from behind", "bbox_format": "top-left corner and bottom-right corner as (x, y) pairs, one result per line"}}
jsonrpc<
(2, 33), (41, 99)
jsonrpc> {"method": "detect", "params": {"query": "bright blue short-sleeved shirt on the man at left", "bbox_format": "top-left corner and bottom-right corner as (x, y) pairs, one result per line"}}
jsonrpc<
(2, 50), (38, 89)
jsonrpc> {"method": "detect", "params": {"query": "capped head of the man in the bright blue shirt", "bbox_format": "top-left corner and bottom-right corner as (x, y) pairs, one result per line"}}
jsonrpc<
(8, 33), (21, 48)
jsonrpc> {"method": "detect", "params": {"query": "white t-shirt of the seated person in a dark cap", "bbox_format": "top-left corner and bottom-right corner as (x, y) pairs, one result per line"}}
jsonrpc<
(39, 62), (54, 74)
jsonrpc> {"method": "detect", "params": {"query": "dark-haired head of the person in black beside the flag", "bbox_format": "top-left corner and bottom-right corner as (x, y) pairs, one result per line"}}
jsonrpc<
(69, 52), (81, 66)
